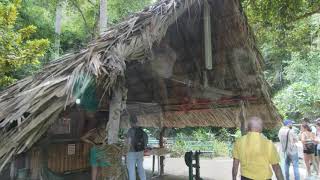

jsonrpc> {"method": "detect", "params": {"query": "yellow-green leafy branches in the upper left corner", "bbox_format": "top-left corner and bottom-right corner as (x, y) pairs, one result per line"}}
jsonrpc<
(0, 1), (49, 87)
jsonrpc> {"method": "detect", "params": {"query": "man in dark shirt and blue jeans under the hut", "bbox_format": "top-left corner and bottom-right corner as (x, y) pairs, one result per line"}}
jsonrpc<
(127, 115), (148, 180)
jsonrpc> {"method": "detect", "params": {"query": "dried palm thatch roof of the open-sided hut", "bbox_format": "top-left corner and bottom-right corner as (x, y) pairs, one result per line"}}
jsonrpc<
(0, 0), (280, 169)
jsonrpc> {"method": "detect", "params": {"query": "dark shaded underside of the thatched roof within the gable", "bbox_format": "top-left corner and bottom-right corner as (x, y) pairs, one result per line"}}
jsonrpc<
(126, 1), (261, 115)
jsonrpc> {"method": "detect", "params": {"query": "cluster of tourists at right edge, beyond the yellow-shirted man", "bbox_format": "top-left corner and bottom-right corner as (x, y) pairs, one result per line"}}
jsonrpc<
(279, 118), (320, 180)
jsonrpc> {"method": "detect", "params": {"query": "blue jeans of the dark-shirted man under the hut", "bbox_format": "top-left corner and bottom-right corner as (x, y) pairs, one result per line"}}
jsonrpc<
(127, 151), (147, 180)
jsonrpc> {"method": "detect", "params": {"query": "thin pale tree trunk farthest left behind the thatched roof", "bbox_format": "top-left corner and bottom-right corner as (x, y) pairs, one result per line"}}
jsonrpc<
(53, 0), (62, 59)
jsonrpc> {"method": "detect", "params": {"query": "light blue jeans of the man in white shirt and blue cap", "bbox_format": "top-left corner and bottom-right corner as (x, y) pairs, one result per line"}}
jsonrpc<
(284, 153), (300, 180)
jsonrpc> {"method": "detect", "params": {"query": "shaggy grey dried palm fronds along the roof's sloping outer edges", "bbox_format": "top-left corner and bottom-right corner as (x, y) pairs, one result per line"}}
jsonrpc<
(0, 0), (279, 171)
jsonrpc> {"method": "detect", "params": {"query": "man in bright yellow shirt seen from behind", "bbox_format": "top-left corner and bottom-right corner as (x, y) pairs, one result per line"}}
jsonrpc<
(232, 117), (284, 180)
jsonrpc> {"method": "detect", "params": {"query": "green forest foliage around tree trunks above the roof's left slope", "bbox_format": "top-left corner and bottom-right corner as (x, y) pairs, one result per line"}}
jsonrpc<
(17, 0), (152, 57)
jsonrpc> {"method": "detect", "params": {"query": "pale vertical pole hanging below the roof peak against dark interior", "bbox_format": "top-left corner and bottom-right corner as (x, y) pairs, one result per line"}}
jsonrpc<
(203, 0), (212, 70)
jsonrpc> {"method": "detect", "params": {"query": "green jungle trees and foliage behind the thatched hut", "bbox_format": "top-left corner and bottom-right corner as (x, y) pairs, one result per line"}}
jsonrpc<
(0, 0), (320, 155)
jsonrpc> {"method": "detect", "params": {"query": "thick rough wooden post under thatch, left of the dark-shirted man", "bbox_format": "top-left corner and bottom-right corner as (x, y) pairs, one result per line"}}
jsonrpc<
(107, 87), (122, 144)
